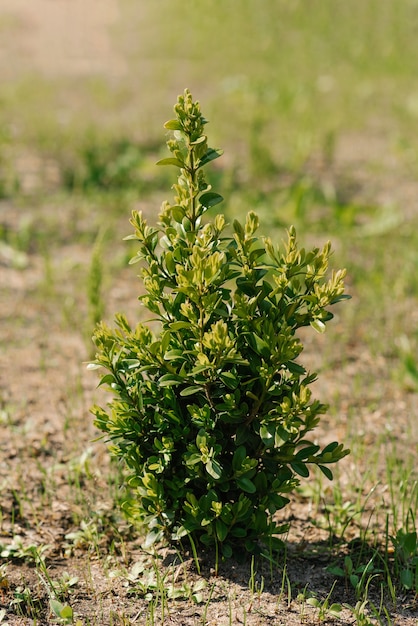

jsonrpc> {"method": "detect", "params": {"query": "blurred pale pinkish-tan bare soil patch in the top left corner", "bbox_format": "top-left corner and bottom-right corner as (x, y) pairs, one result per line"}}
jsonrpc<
(0, 0), (124, 77)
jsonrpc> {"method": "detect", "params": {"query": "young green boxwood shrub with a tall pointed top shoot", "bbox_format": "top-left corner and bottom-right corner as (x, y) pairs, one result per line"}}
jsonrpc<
(92, 90), (348, 557)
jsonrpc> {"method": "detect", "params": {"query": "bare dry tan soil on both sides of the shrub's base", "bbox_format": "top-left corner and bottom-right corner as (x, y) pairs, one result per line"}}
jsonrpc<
(0, 162), (418, 626)
